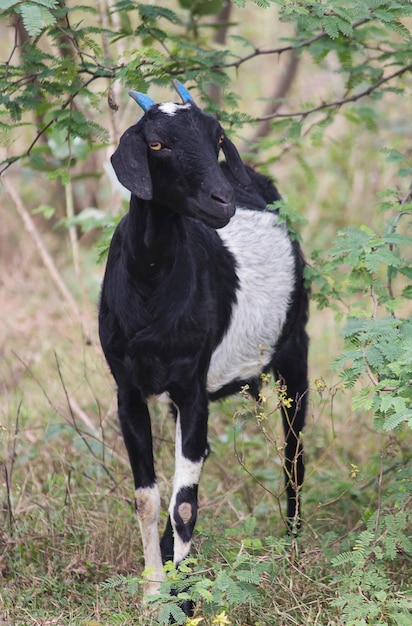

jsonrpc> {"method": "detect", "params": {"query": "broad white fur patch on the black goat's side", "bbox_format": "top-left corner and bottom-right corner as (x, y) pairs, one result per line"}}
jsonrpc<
(207, 209), (295, 393)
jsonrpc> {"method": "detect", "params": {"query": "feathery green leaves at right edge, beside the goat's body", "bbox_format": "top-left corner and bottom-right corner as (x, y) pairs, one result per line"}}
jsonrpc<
(307, 158), (412, 431)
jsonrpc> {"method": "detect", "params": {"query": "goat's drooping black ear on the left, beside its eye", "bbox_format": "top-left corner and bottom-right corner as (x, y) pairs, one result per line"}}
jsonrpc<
(111, 124), (153, 200)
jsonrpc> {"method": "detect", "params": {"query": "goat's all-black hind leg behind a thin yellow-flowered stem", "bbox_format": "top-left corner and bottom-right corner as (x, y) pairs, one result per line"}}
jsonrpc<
(273, 332), (308, 533)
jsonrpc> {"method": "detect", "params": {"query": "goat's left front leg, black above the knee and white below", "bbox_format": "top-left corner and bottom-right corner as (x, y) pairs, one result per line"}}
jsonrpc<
(118, 388), (164, 595)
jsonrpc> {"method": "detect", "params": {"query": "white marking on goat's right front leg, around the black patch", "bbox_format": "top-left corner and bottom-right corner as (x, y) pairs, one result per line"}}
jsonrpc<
(169, 414), (203, 565)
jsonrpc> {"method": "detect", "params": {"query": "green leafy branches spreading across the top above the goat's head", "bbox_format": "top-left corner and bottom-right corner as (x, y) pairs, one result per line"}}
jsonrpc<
(0, 0), (412, 170)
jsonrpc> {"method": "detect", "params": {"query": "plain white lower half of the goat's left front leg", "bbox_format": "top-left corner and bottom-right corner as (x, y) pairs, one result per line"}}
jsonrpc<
(135, 485), (164, 595)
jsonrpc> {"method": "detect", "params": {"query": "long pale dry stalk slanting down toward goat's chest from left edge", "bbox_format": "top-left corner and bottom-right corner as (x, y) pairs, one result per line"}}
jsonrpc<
(2, 177), (93, 345)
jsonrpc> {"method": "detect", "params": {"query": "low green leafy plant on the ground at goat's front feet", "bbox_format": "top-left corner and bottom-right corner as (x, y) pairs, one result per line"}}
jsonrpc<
(102, 517), (316, 626)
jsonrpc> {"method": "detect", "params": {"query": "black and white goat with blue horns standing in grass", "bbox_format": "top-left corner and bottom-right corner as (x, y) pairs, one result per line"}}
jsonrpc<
(99, 81), (308, 604)
